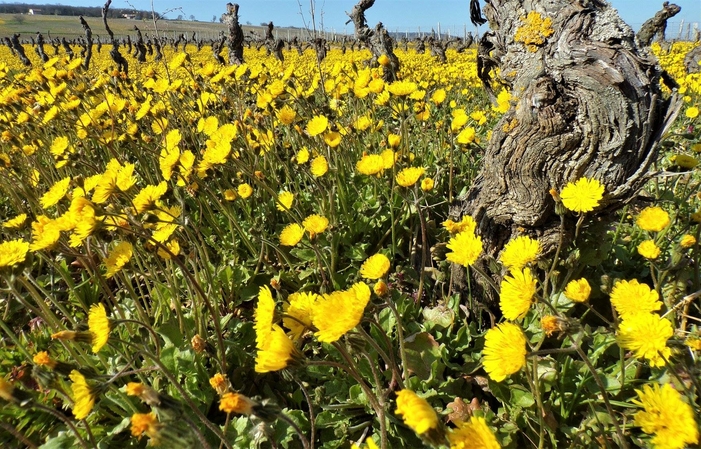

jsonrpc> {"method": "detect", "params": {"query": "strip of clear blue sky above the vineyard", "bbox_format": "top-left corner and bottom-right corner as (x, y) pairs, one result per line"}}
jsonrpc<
(0, 0), (701, 35)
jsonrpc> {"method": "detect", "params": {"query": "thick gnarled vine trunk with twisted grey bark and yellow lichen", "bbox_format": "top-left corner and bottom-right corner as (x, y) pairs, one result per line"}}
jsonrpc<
(451, 0), (680, 298)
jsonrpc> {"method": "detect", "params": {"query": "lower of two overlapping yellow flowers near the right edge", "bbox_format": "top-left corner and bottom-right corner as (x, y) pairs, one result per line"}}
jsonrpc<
(616, 313), (674, 366)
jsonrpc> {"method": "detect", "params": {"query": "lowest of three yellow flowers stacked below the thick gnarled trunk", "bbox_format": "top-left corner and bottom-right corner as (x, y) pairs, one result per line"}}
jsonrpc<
(482, 323), (526, 382)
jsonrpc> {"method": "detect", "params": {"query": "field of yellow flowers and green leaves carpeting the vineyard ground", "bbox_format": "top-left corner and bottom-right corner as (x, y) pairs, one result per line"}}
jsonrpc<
(0, 37), (701, 449)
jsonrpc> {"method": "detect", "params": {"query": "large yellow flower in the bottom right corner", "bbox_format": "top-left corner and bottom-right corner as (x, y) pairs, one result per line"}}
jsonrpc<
(633, 384), (699, 449)
